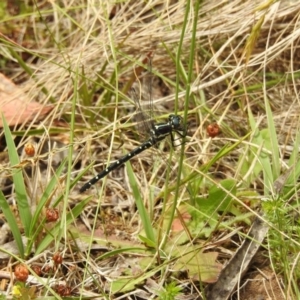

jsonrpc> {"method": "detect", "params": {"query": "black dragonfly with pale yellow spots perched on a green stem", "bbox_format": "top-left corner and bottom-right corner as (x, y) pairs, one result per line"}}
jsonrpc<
(79, 56), (187, 193)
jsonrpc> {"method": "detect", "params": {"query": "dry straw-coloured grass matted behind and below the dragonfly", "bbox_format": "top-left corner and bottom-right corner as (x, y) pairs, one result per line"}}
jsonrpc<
(0, 0), (300, 299)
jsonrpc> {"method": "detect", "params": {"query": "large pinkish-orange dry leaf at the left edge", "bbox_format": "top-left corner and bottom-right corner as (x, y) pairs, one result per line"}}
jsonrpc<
(0, 73), (54, 127)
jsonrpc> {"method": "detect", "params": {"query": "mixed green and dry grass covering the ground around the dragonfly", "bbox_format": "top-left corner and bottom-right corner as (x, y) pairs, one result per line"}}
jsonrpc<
(0, 0), (300, 299)
